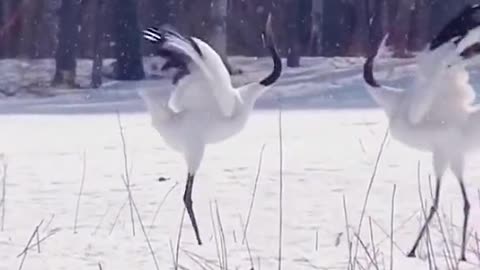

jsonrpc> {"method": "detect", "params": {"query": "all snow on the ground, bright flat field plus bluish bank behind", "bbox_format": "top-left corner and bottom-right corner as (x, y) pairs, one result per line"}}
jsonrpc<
(0, 57), (480, 270)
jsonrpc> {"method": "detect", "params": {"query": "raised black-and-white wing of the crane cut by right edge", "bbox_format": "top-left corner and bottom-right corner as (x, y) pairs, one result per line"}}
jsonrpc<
(409, 5), (480, 124)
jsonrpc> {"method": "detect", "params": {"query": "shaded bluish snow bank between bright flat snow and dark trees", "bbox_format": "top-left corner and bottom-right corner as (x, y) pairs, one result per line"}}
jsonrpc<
(0, 57), (412, 114)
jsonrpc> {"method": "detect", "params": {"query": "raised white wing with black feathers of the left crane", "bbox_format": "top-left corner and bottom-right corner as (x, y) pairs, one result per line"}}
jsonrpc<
(143, 26), (237, 117)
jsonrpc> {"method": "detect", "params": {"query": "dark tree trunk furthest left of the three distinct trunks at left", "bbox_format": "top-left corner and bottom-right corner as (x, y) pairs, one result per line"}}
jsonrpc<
(52, 0), (79, 87)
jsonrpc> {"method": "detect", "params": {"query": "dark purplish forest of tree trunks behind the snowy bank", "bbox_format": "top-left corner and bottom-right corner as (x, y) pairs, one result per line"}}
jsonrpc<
(0, 0), (480, 90)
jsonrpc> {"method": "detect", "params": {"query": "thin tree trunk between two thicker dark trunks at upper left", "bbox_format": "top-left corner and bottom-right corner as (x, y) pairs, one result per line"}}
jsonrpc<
(91, 0), (105, 88)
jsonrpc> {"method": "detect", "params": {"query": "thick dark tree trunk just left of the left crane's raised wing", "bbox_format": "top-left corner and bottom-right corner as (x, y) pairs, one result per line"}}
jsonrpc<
(112, 0), (145, 80)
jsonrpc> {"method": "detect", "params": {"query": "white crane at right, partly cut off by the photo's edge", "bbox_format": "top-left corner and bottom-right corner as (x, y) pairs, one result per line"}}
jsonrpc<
(363, 5), (480, 261)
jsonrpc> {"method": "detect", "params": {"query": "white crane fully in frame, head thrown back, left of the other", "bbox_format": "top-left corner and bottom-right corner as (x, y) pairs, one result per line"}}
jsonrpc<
(140, 15), (282, 245)
